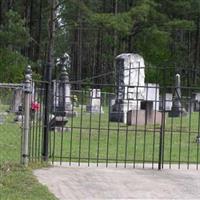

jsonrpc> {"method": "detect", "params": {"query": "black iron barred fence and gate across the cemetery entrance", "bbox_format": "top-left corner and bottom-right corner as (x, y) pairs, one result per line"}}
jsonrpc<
(29, 61), (200, 169)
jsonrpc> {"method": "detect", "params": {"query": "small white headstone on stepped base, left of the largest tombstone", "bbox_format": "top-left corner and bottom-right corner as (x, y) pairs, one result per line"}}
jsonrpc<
(86, 89), (104, 113)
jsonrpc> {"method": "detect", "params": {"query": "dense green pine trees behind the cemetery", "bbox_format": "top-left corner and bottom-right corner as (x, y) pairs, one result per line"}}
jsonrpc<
(0, 0), (200, 84)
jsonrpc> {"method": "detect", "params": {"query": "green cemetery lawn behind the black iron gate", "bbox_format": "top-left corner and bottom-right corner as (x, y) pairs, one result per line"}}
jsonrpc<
(50, 108), (200, 165)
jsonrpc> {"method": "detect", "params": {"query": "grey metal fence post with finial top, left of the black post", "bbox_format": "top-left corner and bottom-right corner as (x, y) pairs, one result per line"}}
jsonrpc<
(21, 66), (32, 167)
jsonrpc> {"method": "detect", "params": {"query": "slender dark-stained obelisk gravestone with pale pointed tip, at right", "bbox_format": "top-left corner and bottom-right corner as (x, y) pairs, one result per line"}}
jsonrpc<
(169, 74), (187, 117)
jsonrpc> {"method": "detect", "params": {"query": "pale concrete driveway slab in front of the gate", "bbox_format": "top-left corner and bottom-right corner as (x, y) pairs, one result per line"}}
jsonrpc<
(34, 165), (200, 200)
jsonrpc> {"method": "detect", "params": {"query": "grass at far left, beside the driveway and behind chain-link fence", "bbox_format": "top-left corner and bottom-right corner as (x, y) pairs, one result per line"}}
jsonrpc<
(0, 110), (56, 200)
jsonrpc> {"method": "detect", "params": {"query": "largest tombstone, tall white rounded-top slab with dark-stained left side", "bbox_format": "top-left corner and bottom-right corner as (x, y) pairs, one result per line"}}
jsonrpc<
(109, 53), (145, 123)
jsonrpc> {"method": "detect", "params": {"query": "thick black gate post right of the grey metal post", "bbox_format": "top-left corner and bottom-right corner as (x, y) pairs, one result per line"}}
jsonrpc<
(42, 63), (52, 161)
